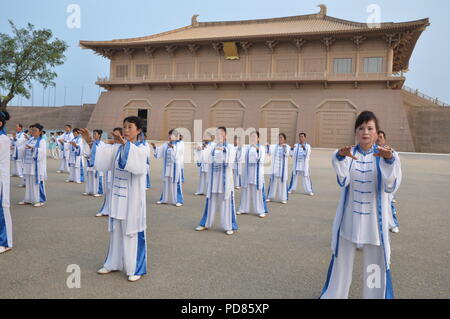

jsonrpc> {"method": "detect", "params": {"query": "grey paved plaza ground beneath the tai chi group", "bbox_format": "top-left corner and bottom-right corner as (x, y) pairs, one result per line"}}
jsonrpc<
(0, 149), (450, 299)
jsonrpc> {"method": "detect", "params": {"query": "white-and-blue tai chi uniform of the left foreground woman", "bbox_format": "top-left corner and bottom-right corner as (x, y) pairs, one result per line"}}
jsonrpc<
(94, 142), (148, 276)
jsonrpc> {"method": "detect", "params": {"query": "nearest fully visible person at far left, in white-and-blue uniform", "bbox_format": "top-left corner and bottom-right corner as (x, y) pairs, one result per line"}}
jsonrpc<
(18, 123), (47, 207)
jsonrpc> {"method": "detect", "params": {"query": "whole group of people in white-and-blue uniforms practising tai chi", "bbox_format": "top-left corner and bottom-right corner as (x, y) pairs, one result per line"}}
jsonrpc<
(0, 111), (401, 298)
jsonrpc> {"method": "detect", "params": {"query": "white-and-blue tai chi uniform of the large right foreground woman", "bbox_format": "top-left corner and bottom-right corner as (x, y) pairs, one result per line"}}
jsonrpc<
(321, 145), (402, 299)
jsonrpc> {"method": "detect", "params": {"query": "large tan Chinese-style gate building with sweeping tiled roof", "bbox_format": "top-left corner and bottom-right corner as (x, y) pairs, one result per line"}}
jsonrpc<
(80, 6), (429, 151)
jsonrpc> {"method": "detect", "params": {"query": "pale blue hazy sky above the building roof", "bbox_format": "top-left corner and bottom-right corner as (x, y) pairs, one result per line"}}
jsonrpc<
(0, 0), (450, 106)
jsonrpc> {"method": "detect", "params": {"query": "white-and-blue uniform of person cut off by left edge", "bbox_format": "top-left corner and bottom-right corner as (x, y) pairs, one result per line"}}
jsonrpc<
(0, 129), (13, 248)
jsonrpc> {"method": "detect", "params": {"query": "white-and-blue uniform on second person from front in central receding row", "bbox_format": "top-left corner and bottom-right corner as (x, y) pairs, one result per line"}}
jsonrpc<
(238, 144), (269, 215)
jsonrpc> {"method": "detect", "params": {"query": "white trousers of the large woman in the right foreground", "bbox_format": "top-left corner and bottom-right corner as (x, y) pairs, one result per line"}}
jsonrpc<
(321, 236), (386, 299)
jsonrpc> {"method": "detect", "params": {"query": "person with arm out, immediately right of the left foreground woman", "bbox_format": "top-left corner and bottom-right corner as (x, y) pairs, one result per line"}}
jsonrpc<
(151, 129), (184, 207)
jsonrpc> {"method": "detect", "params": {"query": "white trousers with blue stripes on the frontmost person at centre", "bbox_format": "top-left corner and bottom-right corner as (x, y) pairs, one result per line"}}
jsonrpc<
(199, 193), (238, 231)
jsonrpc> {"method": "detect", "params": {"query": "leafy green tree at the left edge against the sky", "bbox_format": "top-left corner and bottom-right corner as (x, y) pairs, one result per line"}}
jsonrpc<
(0, 20), (68, 111)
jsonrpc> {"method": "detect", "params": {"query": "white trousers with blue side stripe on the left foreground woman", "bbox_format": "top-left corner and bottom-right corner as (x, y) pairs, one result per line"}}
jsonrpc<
(104, 219), (147, 276)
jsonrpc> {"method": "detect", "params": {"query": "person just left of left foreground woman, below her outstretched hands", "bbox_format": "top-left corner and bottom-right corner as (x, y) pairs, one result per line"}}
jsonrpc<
(83, 130), (105, 197)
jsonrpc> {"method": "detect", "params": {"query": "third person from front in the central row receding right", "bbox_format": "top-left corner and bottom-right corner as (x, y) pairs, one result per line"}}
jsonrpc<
(267, 133), (291, 204)
